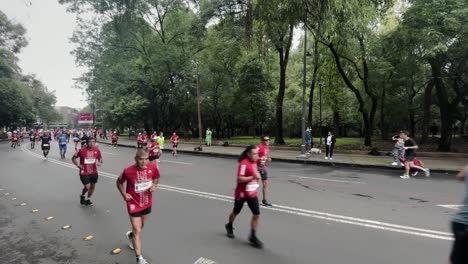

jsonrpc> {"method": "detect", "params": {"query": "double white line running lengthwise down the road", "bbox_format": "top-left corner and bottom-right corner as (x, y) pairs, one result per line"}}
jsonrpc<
(24, 145), (453, 241)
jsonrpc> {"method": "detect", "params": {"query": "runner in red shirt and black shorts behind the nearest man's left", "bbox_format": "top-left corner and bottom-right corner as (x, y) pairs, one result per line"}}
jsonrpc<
(72, 137), (103, 206)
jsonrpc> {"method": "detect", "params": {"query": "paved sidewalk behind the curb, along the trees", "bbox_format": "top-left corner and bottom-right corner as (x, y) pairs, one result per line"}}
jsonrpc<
(98, 138), (468, 173)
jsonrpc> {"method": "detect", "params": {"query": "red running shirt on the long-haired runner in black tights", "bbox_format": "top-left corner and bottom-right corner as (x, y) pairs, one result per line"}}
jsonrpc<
(234, 158), (259, 200)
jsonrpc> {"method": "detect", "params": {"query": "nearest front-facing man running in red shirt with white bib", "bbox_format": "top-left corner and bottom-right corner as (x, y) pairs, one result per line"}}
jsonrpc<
(117, 149), (160, 264)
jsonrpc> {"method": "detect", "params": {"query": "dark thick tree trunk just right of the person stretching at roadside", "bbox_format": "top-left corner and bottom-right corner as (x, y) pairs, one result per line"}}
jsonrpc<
(430, 59), (453, 151)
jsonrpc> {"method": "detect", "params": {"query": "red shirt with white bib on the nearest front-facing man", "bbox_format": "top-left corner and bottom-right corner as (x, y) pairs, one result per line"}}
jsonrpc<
(118, 163), (160, 214)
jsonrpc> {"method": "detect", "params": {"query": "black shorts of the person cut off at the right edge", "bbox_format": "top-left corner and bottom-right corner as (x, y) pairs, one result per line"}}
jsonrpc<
(450, 222), (468, 264)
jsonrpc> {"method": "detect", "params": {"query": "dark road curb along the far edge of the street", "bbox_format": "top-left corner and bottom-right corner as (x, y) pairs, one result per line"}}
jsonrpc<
(98, 141), (458, 174)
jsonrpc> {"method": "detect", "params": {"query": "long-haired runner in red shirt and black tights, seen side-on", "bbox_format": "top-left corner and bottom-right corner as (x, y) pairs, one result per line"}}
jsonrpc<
(225, 145), (263, 248)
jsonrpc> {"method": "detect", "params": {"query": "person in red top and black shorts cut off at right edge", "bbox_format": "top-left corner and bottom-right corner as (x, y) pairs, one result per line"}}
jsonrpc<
(450, 166), (468, 264)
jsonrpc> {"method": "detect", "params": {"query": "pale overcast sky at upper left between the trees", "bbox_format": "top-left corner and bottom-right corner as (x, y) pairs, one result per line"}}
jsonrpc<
(0, 0), (86, 108)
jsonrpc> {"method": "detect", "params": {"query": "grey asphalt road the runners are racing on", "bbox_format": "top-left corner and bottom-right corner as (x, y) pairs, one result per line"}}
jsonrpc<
(0, 142), (463, 264)
